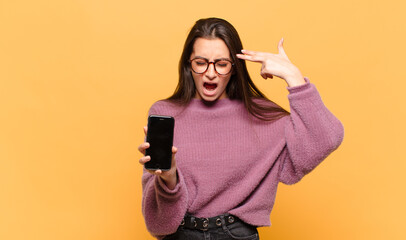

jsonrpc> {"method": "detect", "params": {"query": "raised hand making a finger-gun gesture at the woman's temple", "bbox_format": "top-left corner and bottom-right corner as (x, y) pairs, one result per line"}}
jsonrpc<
(237, 38), (305, 87)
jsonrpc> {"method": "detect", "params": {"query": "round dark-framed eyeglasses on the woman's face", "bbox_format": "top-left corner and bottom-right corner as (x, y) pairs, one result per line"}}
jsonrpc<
(189, 58), (234, 75)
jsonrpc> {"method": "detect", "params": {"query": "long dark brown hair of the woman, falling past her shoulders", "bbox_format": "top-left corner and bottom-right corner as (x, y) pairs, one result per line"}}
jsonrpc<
(168, 18), (289, 121)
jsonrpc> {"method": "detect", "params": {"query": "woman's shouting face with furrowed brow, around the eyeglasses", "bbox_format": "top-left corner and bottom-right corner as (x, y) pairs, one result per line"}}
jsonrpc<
(190, 38), (232, 101)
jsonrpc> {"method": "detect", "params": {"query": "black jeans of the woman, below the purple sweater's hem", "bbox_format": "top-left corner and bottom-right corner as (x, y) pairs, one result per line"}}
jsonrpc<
(164, 218), (259, 240)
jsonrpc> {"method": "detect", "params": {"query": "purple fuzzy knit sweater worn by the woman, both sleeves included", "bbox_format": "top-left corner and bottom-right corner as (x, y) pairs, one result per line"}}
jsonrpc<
(142, 79), (344, 238)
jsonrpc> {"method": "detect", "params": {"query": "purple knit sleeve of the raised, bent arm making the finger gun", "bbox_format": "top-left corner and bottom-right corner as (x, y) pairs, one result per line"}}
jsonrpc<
(279, 78), (344, 184)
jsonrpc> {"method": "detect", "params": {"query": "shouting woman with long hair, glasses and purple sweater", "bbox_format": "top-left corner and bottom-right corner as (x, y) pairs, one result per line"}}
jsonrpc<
(139, 18), (343, 239)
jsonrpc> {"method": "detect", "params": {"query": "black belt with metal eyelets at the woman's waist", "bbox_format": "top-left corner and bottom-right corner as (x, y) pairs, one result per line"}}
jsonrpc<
(180, 214), (241, 231)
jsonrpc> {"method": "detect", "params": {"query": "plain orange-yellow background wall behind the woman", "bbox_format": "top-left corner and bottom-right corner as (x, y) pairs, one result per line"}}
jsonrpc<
(0, 0), (406, 240)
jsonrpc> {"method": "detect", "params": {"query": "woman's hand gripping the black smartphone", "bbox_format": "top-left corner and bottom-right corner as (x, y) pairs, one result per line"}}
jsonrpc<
(138, 126), (178, 189)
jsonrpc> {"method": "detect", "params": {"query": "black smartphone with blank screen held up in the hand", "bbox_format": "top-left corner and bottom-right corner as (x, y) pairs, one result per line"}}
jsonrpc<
(144, 115), (175, 171)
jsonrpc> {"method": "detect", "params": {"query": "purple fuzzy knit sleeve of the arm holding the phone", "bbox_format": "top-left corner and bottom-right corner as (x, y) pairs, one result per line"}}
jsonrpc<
(142, 102), (187, 239)
